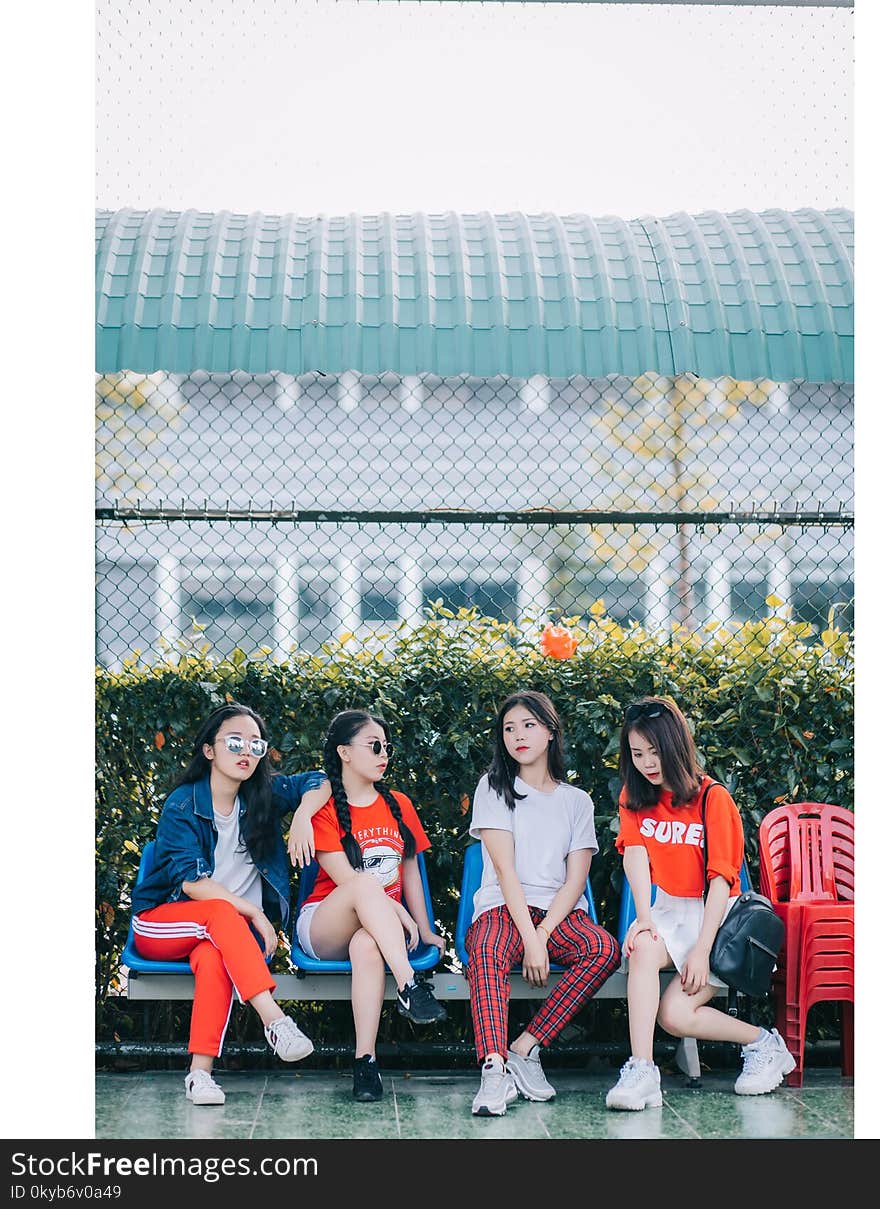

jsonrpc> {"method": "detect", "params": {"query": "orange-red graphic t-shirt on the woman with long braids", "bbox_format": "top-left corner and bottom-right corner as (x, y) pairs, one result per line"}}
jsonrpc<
(303, 789), (430, 907)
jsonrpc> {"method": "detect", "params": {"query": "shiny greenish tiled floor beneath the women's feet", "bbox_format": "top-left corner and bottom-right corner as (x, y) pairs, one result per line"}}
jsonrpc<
(95, 1065), (853, 1140)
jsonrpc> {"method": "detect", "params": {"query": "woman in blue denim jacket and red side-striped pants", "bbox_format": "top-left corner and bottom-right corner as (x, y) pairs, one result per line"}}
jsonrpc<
(132, 701), (330, 1105)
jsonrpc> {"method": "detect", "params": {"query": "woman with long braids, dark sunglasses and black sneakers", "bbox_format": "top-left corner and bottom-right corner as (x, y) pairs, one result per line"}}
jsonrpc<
(291, 710), (446, 1101)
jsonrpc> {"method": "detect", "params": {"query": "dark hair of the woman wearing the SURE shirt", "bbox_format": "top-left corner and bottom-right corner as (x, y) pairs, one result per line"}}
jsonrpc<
(619, 696), (705, 810)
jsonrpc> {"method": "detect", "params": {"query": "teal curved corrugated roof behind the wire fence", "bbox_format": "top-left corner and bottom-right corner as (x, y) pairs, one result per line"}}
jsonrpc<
(95, 209), (853, 382)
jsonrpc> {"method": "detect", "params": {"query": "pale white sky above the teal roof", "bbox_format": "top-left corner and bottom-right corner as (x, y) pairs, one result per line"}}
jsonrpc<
(95, 0), (853, 218)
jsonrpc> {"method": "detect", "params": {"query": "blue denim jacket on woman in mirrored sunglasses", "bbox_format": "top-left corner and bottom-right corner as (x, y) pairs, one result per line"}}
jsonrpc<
(132, 771), (326, 929)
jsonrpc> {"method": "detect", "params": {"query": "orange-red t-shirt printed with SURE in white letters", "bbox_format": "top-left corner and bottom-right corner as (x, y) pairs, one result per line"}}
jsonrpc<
(614, 777), (745, 898)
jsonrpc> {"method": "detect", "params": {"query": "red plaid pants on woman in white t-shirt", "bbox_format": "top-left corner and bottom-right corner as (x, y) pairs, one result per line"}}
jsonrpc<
(464, 906), (620, 1063)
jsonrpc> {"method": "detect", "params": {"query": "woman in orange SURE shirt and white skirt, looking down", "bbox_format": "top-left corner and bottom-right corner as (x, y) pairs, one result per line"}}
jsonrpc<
(606, 696), (795, 1110)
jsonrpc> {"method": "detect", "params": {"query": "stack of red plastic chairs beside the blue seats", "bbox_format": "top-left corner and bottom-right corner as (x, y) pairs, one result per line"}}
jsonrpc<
(758, 802), (855, 1087)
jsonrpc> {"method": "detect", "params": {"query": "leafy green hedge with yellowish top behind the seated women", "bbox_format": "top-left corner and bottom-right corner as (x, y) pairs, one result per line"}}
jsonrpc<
(95, 605), (853, 1039)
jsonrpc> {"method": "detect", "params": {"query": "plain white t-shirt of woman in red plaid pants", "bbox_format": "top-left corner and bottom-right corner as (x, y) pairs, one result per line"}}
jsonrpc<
(469, 775), (598, 919)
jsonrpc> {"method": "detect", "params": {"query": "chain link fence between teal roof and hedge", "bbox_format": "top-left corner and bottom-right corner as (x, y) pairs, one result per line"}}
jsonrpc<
(95, 372), (853, 667)
